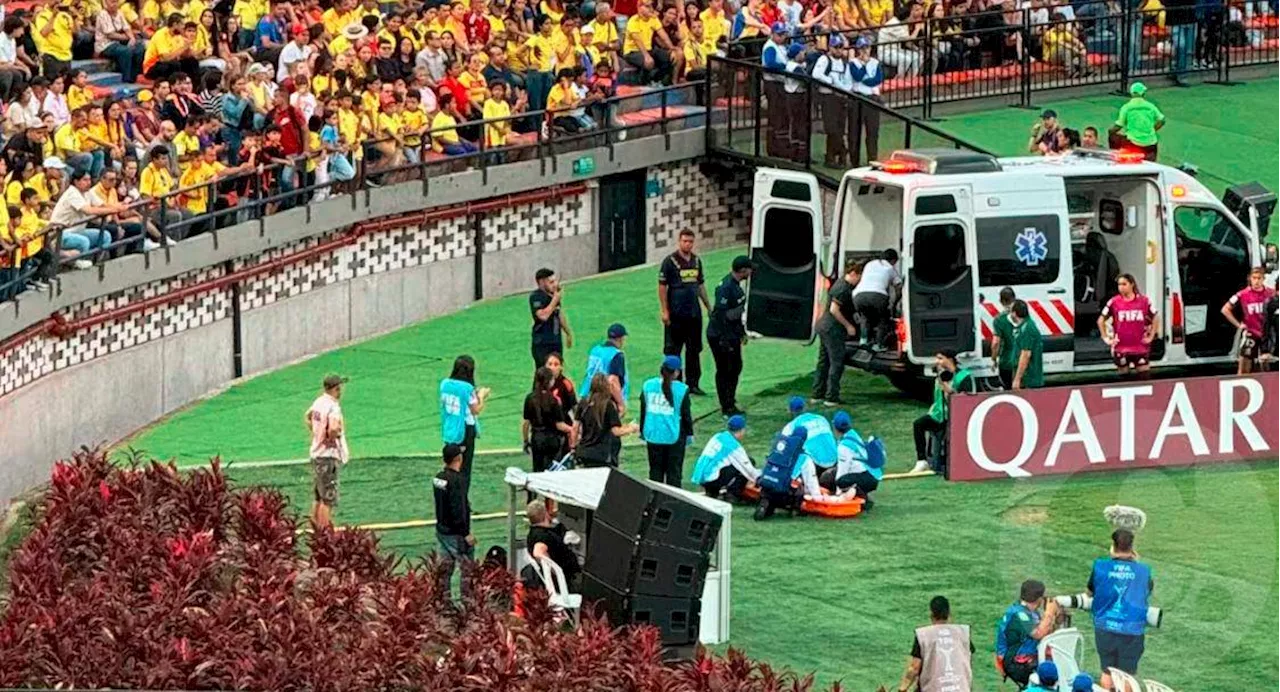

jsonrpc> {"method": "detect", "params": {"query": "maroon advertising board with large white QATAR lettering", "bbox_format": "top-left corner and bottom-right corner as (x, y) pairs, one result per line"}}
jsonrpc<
(947, 372), (1280, 481)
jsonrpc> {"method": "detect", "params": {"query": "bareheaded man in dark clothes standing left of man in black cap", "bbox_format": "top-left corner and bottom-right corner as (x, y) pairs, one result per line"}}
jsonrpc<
(658, 229), (712, 395)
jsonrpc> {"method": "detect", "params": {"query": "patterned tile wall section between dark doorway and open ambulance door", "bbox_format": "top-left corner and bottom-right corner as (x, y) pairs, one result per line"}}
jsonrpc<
(645, 156), (754, 261)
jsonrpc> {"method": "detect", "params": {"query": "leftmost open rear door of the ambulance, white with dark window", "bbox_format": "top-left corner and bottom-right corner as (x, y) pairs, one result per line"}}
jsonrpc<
(746, 169), (826, 340)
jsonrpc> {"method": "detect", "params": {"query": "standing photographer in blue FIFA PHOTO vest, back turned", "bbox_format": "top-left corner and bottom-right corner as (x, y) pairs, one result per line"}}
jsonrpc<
(1085, 528), (1156, 689)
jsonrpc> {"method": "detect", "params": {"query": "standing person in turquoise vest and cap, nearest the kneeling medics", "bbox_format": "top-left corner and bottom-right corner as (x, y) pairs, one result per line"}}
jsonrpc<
(640, 356), (694, 487)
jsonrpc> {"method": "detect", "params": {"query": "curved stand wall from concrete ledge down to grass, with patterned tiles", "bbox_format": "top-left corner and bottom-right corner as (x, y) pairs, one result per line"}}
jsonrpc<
(0, 137), (751, 501)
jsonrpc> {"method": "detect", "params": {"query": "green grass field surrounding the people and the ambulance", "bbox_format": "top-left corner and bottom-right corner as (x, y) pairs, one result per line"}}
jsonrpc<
(117, 81), (1280, 692)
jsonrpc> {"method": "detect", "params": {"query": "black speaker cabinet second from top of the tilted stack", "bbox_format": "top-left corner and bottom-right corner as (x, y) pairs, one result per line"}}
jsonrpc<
(582, 514), (710, 599)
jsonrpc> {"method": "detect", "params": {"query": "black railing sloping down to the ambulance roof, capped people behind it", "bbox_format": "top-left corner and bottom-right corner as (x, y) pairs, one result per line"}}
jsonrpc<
(707, 58), (989, 187)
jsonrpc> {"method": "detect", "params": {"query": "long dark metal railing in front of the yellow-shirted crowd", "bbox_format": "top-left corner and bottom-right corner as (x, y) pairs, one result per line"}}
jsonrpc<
(0, 82), (712, 302)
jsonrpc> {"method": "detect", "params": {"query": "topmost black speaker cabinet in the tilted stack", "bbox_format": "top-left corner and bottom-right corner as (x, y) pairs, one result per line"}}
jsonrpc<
(594, 471), (722, 553)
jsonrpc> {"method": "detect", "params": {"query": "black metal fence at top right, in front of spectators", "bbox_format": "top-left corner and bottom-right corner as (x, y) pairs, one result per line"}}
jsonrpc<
(732, 0), (1280, 119)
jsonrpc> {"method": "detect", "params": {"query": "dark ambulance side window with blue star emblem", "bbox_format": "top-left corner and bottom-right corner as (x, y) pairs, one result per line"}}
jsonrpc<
(977, 214), (1061, 287)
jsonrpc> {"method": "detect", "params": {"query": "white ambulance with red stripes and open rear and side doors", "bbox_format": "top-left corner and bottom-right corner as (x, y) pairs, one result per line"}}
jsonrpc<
(746, 150), (1276, 391)
